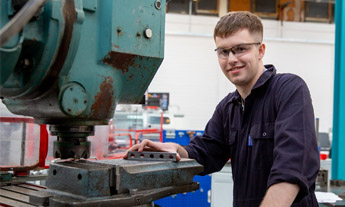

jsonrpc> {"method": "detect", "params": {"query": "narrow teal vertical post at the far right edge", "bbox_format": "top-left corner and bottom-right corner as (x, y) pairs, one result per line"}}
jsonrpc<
(332, 0), (345, 180)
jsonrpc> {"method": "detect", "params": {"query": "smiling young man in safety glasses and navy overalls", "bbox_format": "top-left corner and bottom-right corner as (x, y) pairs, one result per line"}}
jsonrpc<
(125, 12), (320, 207)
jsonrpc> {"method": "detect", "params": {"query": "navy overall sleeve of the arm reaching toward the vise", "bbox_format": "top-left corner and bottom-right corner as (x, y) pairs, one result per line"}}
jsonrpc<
(185, 98), (230, 175)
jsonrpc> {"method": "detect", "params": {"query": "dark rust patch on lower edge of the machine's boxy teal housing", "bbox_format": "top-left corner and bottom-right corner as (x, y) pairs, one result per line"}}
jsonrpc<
(103, 51), (138, 74)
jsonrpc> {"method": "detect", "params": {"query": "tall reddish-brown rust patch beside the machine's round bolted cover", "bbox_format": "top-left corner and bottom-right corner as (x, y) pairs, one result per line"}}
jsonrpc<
(91, 77), (114, 119)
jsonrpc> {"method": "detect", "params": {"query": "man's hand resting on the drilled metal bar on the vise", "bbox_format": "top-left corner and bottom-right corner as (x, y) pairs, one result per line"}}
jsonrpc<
(123, 139), (188, 161)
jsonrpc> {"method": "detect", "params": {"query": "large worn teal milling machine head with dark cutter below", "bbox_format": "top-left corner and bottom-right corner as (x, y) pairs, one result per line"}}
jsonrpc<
(0, 0), (166, 159)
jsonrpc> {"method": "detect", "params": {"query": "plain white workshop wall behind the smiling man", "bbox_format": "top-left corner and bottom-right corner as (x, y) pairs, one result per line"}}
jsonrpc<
(149, 14), (334, 132)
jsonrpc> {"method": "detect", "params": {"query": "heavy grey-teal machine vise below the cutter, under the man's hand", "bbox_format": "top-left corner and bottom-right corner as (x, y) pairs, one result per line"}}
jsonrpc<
(25, 159), (203, 207)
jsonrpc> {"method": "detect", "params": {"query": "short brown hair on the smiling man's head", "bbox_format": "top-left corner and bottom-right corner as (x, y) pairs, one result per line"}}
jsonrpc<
(213, 11), (263, 42)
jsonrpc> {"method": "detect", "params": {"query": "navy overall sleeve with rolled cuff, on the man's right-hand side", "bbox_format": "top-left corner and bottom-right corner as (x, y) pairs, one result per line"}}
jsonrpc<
(267, 75), (320, 200)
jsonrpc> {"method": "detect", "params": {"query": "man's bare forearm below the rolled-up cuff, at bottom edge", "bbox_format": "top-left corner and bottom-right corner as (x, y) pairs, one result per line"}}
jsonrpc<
(260, 182), (299, 207)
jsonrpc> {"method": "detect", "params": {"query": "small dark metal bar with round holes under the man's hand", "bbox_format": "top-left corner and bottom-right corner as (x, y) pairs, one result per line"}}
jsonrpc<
(127, 151), (177, 162)
